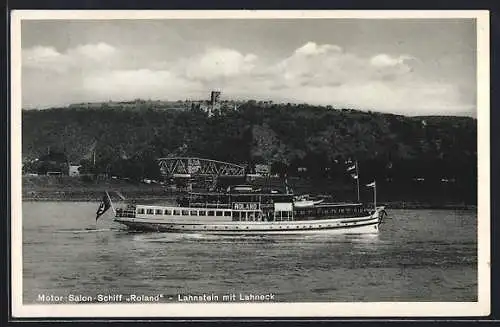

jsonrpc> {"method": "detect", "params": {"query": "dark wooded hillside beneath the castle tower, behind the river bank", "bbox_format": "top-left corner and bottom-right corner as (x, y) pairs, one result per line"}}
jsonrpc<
(22, 101), (477, 188)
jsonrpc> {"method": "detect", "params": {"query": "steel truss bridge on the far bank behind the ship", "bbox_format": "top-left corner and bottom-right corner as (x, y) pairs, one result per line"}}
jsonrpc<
(158, 157), (245, 177)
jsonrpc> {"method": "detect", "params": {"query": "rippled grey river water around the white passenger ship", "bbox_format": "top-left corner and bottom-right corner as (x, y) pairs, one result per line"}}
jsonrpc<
(23, 202), (477, 304)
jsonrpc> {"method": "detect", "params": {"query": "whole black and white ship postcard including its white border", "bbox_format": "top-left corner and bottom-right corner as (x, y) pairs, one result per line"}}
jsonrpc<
(10, 10), (490, 318)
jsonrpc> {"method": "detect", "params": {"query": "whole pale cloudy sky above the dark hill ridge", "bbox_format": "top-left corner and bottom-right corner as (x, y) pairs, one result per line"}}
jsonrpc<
(21, 19), (476, 116)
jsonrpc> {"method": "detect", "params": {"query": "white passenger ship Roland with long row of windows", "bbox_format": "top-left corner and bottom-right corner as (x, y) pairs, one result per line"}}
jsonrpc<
(106, 187), (386, 235)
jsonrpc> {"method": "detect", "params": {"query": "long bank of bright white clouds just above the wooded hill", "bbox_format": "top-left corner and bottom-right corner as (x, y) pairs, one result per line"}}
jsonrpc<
(23, 42), (474, 114)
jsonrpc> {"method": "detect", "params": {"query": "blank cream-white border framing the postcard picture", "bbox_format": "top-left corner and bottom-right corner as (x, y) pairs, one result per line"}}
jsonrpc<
(10, 10), (490, 318)
